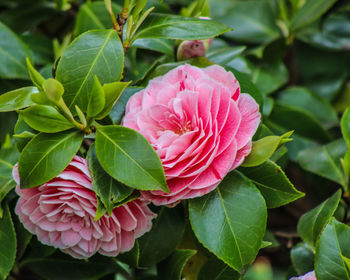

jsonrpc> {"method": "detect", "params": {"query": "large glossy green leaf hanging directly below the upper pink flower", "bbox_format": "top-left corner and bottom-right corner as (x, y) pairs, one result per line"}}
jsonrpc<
(189, 171), (267, 271)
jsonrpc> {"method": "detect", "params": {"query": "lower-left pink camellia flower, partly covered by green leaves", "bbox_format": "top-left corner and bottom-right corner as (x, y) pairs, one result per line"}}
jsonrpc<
(13, 156), (156, 258)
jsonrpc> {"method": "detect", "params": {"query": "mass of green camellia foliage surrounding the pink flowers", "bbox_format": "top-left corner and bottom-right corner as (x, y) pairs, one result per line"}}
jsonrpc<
(0, 0), (350, 280)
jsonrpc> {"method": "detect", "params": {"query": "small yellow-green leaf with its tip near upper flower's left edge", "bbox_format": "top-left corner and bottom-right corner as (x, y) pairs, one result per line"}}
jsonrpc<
(96, 82), (131, 119)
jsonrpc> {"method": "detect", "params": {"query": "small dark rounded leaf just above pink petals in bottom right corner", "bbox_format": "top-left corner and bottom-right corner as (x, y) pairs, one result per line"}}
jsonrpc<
(290, 243), (314, 275)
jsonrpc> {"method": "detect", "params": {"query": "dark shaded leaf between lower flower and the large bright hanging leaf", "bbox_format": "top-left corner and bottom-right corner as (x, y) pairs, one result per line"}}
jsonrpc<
(138, 206), (185, 267)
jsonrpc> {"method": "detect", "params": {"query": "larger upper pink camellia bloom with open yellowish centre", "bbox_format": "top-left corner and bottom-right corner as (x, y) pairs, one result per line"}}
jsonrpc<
(122, 65), (260, 206)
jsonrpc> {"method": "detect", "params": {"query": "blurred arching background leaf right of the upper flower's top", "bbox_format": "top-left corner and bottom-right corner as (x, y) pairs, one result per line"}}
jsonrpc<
(278, 87), (338, 126)
